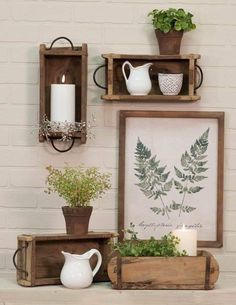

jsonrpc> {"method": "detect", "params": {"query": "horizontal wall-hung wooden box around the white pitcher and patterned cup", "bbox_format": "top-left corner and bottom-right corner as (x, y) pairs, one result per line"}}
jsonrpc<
(101, 53), (201, 102)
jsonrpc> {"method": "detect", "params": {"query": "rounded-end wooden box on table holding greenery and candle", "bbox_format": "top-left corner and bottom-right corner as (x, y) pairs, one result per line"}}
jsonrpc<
(108, 251), (219, 290)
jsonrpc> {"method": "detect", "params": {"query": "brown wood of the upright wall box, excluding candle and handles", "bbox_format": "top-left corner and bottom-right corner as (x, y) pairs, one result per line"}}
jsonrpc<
(39, 43), (88, 143)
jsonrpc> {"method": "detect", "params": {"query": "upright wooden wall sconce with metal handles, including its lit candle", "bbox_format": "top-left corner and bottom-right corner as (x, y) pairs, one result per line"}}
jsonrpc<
(39, 37), (88, 152)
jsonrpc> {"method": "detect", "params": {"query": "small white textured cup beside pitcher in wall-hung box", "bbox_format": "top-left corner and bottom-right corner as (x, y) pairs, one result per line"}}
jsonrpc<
(158, 73), (183, 95)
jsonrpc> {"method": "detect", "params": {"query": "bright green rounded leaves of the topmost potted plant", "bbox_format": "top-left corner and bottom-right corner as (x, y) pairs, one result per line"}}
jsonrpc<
(148, 8), (196, 33)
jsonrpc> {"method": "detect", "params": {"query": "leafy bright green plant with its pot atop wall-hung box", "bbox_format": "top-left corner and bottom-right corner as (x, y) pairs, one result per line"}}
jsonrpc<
(148, 8), (196, 55)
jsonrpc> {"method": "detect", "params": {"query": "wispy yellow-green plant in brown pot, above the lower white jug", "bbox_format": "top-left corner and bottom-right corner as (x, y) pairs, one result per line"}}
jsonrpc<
(45, 165), (111, 234)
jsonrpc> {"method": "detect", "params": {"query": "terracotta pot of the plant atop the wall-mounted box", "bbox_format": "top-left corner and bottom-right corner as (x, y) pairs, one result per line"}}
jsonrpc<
(155, 30), (184, 55)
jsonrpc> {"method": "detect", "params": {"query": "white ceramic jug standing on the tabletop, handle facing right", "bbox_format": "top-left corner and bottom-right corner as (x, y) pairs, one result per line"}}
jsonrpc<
(60, 249), (102, 289)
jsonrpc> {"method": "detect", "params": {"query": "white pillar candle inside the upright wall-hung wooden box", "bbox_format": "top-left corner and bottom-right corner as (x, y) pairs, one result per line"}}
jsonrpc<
(50, 84), (75, 123)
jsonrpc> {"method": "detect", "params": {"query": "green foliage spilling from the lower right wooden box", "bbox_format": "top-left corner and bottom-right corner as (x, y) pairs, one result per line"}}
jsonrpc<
(114, 223), (187, 257)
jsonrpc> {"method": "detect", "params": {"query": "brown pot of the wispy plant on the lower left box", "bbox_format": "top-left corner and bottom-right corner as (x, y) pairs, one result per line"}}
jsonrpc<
(62, 206), (93, 235)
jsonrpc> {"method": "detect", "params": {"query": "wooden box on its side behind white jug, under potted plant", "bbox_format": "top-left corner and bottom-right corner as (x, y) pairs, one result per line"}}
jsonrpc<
(14, 232), (114, 286)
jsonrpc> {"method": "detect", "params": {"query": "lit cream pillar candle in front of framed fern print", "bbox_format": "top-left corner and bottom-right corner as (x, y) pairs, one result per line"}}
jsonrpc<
(172, 225), (197, 256)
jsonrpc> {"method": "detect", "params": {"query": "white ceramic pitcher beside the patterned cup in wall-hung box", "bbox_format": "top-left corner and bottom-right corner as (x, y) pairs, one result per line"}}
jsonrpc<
(122, 61), (152, 95)
